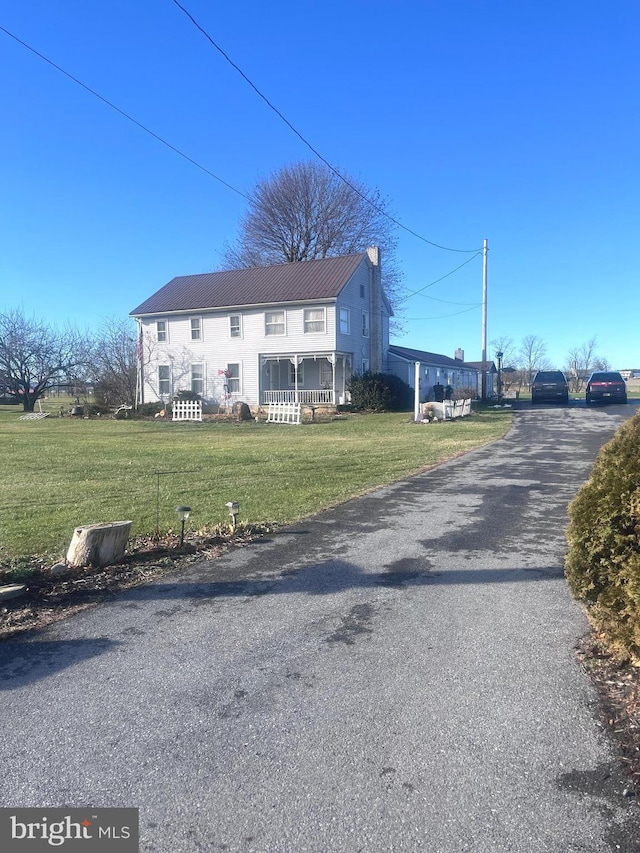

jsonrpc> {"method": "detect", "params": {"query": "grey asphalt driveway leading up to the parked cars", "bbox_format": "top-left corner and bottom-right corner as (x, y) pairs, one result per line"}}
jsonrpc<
(0, 407), (640, 853)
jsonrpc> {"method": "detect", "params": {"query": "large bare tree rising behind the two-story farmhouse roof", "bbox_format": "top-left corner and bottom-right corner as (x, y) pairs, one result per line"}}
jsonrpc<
(223, 161), (401, 325)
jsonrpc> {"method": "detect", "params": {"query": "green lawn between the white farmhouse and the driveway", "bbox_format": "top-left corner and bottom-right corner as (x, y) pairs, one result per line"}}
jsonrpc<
(0, 407), (511, 562)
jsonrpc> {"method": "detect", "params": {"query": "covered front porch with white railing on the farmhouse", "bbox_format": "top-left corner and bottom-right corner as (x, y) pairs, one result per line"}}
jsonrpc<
(259, 352), (352, 406)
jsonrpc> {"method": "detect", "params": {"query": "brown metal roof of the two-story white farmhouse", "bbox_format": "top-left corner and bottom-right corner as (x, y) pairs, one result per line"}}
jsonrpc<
(131, 252), (367, 317)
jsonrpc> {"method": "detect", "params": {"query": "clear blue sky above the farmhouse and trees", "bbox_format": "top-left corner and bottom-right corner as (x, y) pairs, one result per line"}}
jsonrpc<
(0, 0), (640, 368)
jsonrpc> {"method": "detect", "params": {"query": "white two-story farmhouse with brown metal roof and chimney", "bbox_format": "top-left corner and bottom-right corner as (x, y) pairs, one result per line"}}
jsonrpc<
(131, 247), (392, 406)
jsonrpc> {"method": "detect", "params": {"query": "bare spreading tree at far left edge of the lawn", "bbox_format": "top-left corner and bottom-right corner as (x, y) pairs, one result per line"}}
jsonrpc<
(0, 308), (89, 412)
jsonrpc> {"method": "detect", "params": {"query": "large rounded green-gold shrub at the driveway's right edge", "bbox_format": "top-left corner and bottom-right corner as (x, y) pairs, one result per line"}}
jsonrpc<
(565, 412), (640, 657)
